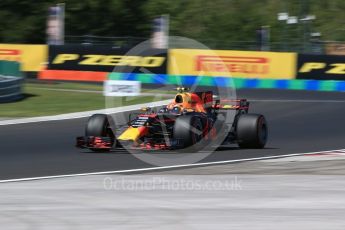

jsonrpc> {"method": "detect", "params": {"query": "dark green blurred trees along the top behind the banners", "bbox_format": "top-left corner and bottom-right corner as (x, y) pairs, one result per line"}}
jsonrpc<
(0, 0), (345, 43)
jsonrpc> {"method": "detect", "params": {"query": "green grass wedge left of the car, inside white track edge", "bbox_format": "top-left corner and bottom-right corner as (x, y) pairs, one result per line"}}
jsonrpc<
(0, 83), (166, 118)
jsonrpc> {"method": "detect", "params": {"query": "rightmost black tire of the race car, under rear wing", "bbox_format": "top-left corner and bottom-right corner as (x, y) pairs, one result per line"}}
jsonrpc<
(236, 114), (268, 149)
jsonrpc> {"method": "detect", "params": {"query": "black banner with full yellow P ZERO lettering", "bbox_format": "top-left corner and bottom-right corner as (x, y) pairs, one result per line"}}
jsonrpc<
(48, 45), (167, 74)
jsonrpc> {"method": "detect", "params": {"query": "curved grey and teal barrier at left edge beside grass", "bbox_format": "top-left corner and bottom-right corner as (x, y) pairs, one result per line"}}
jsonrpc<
(0, 61), (23, 103)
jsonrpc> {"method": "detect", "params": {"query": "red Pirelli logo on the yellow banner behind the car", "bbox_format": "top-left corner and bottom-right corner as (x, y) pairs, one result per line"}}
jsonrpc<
(195, 55), (270, 74)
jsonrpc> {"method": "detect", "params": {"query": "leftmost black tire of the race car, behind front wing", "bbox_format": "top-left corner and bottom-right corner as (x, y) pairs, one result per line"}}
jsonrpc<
(85, 114), (114, 152)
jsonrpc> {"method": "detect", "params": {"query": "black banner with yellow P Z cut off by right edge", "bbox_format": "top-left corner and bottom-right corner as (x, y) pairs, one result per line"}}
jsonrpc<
(297, 54), (345, 80)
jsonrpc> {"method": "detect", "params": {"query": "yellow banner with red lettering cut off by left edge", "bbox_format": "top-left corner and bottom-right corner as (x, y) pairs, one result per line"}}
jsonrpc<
(0, 44), (48, 72)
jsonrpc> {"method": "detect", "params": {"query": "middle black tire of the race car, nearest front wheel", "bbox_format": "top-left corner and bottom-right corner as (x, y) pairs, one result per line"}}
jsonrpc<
(173, 115), (203, 148)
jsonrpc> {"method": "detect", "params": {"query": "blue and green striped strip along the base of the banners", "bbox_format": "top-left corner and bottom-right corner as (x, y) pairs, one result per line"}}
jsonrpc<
(108, 73), (345, 92)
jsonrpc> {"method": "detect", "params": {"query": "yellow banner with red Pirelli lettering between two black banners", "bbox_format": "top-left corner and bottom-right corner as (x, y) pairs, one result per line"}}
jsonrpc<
(168, 49), (297, 79)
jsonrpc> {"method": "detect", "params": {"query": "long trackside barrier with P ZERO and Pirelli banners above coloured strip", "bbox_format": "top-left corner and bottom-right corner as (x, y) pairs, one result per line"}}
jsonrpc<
(38, 45), (345, 91)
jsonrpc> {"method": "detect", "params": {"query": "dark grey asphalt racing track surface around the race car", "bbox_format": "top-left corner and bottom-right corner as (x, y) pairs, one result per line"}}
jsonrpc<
(0, 89), (345, 180)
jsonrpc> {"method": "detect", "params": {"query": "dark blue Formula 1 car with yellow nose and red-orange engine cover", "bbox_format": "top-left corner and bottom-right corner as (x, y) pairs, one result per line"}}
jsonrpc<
(76, 87), (268, 152)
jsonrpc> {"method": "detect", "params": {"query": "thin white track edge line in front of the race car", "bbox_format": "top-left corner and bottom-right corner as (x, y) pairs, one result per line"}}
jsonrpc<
(0, 149), (345, 184)
